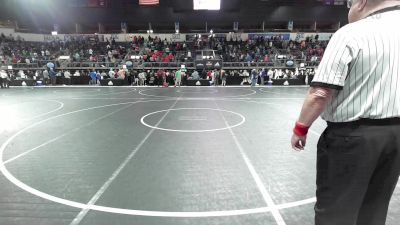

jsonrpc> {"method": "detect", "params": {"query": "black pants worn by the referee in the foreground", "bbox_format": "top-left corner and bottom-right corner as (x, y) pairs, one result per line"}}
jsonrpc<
(315, 120), (400, 225)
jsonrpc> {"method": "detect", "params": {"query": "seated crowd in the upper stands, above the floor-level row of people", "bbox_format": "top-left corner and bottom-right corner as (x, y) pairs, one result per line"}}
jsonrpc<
(0, 31), (327, 66)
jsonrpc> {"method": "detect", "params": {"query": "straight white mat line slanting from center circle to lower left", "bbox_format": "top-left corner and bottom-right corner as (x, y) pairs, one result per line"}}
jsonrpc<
(70, 99), (179, 225)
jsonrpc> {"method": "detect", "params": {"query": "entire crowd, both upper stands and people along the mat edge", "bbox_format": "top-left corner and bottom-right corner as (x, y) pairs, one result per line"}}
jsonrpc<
(0, 31), (327, 85)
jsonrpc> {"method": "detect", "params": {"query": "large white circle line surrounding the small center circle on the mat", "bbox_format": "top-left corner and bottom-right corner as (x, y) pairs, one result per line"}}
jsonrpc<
(0, 99), (316, 218)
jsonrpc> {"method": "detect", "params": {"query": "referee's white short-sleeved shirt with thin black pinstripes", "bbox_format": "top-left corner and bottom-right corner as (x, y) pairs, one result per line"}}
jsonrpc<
(311, 7), (400, 122)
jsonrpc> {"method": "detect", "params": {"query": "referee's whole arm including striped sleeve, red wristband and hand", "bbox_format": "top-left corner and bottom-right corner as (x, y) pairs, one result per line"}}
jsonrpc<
(291, 28), (358, 151)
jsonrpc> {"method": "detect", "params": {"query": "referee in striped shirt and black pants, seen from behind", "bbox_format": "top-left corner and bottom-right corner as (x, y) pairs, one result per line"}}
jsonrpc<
(291, 0), (400, 225)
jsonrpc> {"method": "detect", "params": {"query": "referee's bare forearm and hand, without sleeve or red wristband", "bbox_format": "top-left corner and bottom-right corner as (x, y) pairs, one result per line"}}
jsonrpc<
(291, 87), (335, 151)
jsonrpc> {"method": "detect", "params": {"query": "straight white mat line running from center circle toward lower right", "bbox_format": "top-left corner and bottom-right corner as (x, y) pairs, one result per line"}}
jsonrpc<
(215, 102), (286, 225)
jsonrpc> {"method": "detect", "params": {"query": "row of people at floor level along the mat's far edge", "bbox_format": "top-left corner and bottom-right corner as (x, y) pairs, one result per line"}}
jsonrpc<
(1, 65), (314, 86)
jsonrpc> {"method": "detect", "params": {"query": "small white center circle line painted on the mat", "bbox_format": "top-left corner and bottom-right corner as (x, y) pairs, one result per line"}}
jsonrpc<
(140, 108), (246, 133)
